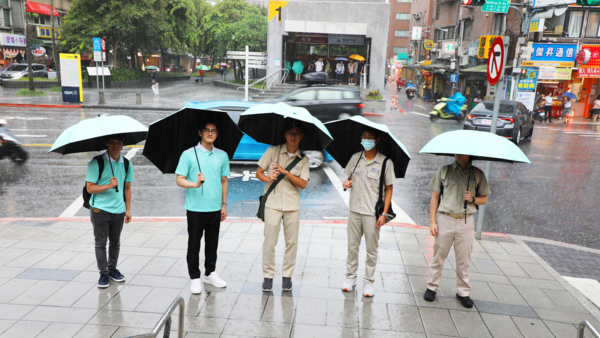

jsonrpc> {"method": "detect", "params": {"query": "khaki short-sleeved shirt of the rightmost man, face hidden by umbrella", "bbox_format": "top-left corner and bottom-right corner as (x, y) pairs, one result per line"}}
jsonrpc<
(429, 162), (492, 215)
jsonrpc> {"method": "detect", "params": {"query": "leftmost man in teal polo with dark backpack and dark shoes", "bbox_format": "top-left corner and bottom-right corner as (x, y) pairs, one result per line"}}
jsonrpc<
(86, 135), (133, 288)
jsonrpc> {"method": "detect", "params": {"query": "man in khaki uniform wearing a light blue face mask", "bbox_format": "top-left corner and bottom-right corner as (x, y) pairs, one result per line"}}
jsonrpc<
(342, 128), (396, 297)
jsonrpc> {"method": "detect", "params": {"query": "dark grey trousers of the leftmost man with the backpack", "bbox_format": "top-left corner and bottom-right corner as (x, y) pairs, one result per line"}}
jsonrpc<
(90, 208), (125, 273)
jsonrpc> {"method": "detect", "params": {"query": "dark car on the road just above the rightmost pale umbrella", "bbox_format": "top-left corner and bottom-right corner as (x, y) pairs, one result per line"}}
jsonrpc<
(464, 100), (534, 144)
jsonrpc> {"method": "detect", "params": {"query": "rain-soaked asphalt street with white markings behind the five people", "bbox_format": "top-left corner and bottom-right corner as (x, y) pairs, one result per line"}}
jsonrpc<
(0, 86), (600, 249)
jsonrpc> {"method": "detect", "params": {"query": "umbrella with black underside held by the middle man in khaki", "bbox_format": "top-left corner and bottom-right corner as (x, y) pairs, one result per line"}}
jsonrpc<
(238, 103), (333, 150)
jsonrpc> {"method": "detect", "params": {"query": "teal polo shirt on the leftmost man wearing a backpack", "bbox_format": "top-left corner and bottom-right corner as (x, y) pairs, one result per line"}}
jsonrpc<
(85, 153), (133, 214)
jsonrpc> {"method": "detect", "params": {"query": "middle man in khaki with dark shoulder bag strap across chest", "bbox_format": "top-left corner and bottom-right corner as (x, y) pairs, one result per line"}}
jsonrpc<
(256, 123), (309, 291)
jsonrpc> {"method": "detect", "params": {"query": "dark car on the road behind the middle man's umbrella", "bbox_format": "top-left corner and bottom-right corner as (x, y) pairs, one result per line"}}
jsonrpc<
(266, 85), (365, 122)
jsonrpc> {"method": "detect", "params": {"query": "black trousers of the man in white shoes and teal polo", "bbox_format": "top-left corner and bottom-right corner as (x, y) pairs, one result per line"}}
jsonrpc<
(187, 210), (221, 279)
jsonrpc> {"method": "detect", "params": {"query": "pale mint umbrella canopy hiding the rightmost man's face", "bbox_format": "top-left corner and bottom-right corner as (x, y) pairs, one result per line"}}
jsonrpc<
(419, 130), (531, 164)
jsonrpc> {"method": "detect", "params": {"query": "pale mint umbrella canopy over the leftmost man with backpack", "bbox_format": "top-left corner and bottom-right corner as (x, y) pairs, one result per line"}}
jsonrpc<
(49, 115), (148, 155)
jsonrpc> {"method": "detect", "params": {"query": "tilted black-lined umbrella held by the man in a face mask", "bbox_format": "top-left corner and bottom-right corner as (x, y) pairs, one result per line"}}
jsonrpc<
(325, 115), (410, 178)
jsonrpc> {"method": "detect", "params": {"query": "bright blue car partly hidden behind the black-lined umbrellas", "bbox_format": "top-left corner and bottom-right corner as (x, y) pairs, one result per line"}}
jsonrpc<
(185, 100), (333, 169)
